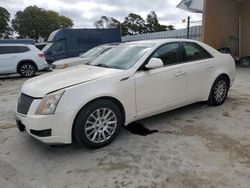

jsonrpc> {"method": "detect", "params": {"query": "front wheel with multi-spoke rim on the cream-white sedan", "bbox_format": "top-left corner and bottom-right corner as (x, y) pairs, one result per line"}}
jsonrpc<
(73, 99), (123, 149)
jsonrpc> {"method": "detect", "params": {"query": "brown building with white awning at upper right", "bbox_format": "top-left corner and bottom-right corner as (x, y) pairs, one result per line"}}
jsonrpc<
(177, 0), (250, 56)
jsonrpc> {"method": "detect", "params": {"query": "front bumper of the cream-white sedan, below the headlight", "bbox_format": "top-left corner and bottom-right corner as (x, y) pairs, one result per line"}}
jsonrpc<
(16, 112), (73, 144)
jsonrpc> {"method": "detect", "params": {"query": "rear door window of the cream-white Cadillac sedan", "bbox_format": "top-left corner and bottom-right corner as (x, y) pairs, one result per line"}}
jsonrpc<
(183, 42), (211, 61)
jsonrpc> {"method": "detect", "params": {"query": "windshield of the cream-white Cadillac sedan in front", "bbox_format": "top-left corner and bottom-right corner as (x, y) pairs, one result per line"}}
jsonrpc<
(89, 44), (154, 70)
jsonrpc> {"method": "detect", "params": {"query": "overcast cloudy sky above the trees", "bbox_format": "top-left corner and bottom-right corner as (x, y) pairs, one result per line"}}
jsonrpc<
(0, 0), (201, 29)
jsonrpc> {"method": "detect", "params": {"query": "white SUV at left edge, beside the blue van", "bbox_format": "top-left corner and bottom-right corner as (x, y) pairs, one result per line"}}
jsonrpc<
(0, 44), (48, 77)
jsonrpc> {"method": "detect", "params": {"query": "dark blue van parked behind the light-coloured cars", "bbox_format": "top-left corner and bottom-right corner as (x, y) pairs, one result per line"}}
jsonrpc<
(42, 28), (121, 63)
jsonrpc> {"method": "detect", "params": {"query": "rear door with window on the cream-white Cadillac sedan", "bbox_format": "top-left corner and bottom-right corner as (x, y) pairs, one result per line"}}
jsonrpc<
(182, 42), (215, 99)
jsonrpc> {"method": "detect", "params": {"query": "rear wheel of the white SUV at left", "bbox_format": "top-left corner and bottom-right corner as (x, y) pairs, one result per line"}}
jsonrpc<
(17, 62), (36, 78)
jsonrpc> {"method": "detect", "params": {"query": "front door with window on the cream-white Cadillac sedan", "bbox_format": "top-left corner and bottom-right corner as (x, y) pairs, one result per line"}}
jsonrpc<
(135, 43), (187, 116)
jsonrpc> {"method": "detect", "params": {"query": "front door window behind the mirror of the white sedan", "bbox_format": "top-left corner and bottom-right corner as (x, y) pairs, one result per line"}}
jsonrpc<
(151, 43), (180, 66)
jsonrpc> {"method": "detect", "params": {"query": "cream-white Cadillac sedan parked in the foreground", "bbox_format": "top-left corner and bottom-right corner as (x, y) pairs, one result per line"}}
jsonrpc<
(16, 39), (235, 148)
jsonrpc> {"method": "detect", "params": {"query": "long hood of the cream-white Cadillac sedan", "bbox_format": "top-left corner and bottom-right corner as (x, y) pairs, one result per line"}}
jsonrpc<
(21, 65), (123, 98)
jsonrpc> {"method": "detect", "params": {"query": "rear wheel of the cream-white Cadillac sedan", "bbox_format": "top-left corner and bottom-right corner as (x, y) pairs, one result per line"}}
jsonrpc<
(208, 76), (229, 106)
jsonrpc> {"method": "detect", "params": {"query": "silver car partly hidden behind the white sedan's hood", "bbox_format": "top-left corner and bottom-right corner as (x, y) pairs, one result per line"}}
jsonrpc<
(52, 43), (118, 69)
